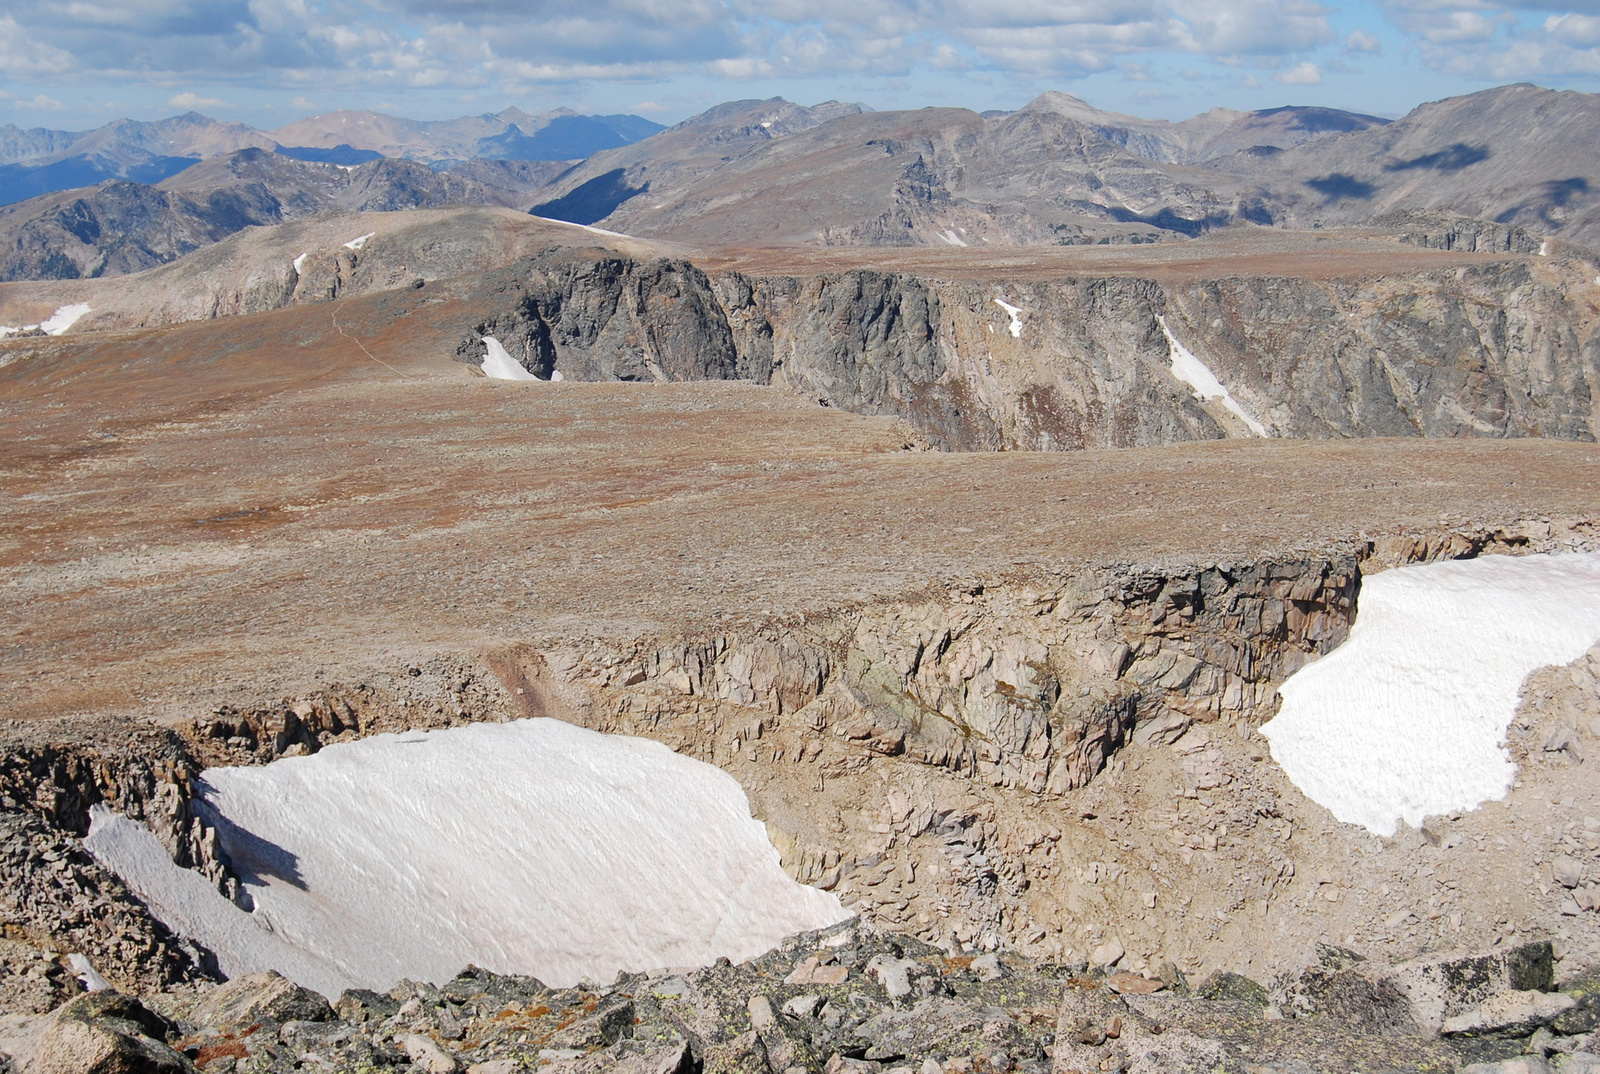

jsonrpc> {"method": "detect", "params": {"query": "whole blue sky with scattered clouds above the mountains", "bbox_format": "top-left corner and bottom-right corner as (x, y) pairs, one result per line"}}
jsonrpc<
(0, 0), (1600, 130)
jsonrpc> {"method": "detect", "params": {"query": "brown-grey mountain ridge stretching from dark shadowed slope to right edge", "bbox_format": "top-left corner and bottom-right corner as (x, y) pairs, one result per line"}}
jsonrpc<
(533, 85), (1600, 246)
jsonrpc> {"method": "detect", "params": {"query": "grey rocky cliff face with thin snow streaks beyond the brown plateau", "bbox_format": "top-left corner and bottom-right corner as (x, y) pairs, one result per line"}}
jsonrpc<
(458, 250), (1600, 450)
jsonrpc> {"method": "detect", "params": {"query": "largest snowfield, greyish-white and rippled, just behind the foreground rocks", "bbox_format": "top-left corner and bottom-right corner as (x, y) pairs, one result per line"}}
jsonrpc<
(86, 719), (848, 996)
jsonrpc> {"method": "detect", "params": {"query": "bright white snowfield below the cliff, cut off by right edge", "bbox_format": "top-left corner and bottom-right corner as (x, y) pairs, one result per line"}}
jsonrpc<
(1261, 554), (1600, 837)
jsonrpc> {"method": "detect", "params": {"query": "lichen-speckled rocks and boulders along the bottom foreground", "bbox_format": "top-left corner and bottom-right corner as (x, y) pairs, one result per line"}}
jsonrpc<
(0, 922), (1600, 1074)
